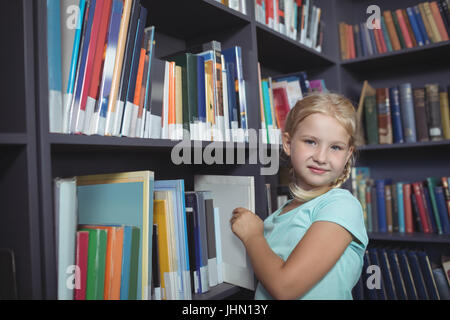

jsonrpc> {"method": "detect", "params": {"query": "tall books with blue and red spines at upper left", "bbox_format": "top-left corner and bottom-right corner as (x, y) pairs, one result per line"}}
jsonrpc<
(47, 0), (155, 135)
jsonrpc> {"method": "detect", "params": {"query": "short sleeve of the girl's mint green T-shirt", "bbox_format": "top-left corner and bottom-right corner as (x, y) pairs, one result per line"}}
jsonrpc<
(312, 189), (369, 248)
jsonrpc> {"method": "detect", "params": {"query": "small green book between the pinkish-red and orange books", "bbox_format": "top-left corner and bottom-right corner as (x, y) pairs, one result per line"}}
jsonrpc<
(80, 228), (108, 300)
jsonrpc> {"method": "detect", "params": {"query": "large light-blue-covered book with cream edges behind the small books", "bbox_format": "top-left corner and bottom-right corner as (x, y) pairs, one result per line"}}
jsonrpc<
(77, 171), (154, 300)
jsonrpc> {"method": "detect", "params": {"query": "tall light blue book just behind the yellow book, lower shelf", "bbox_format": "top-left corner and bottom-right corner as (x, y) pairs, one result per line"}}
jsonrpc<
(155, 179), (192, 300)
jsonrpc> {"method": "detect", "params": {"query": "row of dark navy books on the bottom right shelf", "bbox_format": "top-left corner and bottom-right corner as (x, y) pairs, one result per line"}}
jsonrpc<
(352, 247), (450, 300)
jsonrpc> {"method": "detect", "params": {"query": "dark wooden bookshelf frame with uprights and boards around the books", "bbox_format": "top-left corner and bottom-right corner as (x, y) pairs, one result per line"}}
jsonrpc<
(0, 0), (450, 300)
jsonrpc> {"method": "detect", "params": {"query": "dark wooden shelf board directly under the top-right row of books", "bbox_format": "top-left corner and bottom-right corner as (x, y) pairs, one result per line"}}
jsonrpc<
(341, 41), (450, 72)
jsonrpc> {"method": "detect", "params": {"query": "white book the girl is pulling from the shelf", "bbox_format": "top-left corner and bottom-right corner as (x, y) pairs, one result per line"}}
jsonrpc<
(194, 175), (255, 290)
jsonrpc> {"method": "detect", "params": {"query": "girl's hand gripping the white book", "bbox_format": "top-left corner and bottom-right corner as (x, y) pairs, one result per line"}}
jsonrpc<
(230, 208), (264, 244)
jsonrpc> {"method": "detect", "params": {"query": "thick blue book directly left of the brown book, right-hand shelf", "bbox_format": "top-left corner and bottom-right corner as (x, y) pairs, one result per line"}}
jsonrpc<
(399, 83), (417, 142)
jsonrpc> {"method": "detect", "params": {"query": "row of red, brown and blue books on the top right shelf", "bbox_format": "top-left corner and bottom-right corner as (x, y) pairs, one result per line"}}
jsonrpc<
(339, 0), (450, 60)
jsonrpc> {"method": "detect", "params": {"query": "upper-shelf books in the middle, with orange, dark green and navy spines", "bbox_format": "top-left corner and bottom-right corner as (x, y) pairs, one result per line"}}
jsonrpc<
(159, 41), (248, 142)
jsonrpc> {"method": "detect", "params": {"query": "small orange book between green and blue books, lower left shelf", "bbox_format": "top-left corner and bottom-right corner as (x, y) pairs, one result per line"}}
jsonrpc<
(82, 225), (123, 300)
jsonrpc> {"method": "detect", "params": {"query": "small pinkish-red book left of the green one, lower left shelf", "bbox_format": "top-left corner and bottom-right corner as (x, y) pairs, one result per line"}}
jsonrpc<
(74, 231), (89, 300)
